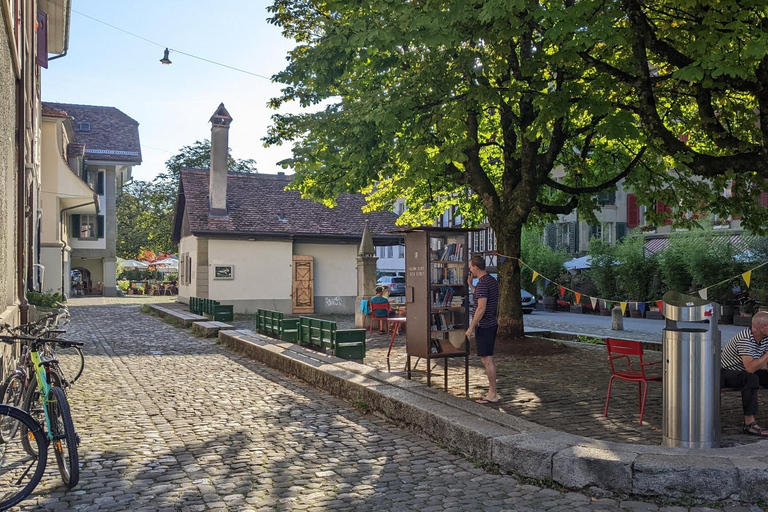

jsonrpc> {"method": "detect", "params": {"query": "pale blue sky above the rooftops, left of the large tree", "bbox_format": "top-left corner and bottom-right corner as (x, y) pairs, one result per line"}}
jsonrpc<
(42, 0), (294, 180)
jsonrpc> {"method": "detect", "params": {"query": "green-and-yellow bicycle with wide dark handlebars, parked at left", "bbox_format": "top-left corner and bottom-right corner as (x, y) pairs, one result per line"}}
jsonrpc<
(0, 335), (82, 489)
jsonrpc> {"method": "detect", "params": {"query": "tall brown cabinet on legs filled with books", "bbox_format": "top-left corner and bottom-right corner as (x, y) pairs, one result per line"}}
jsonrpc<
(405, 227), (469, 396)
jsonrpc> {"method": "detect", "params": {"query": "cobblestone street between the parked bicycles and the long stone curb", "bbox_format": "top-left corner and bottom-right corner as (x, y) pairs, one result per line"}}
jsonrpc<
(6, 299), (760, 512)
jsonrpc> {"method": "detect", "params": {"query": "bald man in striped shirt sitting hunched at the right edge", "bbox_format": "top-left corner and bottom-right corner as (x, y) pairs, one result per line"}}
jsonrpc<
(720, 311), (768, 438)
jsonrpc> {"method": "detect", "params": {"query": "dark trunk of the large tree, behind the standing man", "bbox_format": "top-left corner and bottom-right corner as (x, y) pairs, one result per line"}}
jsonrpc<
(496, 223), (525, 338)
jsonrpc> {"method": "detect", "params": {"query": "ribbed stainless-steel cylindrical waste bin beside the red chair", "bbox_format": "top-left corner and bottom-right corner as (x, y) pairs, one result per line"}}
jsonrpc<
(662, 292), (720, 448)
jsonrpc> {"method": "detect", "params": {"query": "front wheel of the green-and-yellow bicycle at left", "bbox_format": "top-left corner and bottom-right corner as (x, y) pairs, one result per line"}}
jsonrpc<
(46, 386), (80, 489)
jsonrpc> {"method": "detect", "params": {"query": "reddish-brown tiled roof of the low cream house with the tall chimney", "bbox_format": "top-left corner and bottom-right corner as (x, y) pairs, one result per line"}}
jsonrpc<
(176, 169), (402, 243)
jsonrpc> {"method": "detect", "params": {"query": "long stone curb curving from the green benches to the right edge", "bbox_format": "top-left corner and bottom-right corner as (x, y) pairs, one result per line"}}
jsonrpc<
(219, 330), (768, 502)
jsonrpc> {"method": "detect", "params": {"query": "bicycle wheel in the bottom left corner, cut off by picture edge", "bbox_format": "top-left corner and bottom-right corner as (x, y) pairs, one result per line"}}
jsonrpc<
(0, 405), (48, 510)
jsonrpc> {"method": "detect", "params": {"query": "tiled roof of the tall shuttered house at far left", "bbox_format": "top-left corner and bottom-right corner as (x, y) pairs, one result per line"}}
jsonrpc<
(43, 102), (141, 164)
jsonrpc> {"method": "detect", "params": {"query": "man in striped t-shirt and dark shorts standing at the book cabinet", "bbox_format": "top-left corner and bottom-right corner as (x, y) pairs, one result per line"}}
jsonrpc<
(466, 254), (499, 404)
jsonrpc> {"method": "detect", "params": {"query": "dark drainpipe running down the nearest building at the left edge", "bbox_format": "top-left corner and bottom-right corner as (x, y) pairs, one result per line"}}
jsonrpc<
(16, 65), (29, 324)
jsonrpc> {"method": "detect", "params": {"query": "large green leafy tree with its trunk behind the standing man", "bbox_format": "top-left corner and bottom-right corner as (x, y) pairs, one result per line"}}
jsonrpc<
(266, 0), (768, 336)
